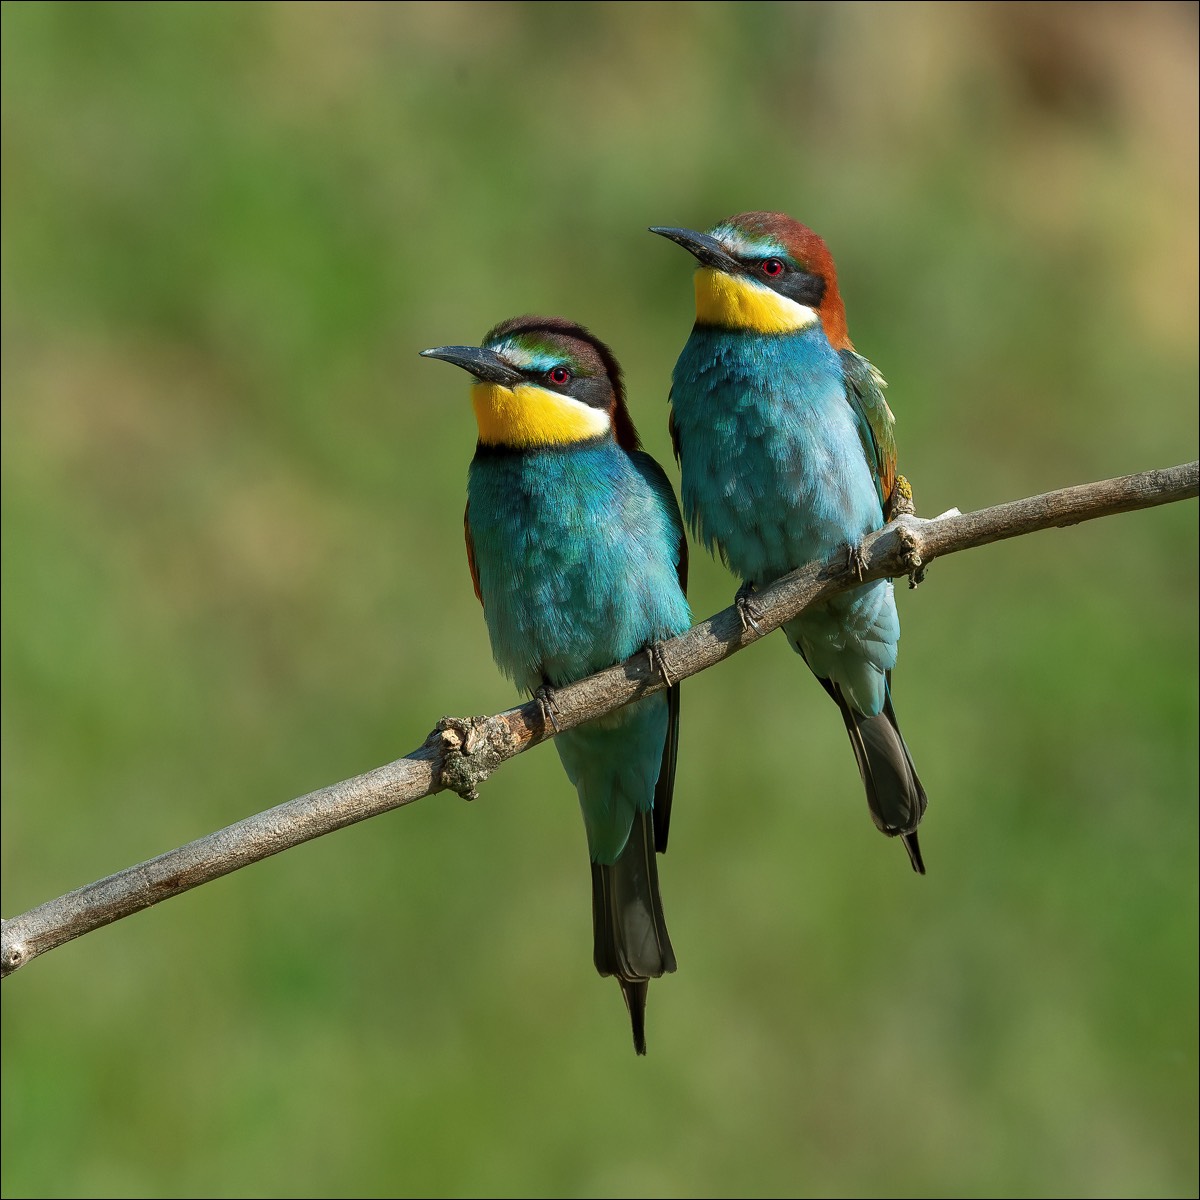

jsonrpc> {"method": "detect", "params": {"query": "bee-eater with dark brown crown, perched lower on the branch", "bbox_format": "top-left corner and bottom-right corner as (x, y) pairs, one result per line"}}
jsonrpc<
(421, 317), (690, 1054)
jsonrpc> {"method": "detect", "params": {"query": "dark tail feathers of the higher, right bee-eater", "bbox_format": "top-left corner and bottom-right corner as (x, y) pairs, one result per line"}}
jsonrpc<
(822, 680), (929, 875)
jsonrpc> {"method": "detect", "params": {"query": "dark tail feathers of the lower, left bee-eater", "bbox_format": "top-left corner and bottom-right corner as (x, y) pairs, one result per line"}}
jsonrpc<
(592, 812), (676, 1054)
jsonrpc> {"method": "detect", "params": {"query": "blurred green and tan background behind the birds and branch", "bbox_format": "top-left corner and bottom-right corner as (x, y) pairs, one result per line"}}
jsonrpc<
(2, 4), (1198, 1196)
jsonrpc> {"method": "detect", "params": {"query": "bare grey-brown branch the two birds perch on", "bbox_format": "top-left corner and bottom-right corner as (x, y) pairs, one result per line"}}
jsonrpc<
(0, 462), (1200, 976)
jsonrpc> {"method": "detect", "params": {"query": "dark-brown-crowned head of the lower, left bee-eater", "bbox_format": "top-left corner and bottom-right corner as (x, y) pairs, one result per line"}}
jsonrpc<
(421, 317), (638, 450)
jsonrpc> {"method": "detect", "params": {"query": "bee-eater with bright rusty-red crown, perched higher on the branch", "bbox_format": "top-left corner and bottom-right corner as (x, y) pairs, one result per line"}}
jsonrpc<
(650, 212), (925, 875)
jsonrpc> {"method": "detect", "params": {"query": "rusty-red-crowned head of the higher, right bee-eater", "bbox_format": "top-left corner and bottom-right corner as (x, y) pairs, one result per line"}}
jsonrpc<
(650, 212), (851, 349)
